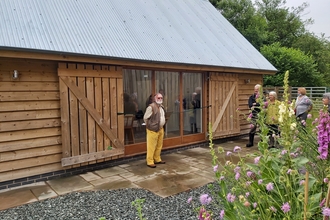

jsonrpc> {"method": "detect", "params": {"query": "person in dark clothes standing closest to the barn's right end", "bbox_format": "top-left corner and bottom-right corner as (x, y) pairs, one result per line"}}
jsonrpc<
(246, 84), (261, 147)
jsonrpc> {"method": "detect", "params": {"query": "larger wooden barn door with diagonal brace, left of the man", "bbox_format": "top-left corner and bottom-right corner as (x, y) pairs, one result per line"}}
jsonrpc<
(58, 63), (124, 166)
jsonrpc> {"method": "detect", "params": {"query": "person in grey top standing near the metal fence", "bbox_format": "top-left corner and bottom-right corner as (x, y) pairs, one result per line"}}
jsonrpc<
(295, 87), (313, 121)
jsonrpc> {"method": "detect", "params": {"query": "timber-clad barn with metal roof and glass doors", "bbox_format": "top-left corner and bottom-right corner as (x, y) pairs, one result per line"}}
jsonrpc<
(0, 0), (276, 189)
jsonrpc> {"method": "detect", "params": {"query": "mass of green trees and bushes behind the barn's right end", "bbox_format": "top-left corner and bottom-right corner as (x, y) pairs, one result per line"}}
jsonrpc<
(210, 0), (330, 86)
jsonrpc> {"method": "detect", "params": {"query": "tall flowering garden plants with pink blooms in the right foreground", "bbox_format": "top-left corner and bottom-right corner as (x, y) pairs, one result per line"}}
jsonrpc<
(192, 72), (330, 220)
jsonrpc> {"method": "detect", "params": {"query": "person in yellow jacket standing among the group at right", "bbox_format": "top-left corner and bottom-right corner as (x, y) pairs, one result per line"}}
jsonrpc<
(266, 91), (281, 148)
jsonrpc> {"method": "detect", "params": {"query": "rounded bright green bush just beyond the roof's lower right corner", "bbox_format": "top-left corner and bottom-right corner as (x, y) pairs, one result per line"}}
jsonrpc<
(260, 43), (323, 87)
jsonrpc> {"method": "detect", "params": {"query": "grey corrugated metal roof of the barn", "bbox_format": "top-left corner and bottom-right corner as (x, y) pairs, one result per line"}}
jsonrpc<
(0, 0), (276, 71)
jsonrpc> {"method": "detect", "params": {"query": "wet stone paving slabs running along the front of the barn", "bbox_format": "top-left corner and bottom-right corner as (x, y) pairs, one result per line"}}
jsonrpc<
(0, 138), (257, 210)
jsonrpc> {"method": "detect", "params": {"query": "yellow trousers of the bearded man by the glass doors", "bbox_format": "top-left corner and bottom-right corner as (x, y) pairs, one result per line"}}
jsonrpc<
(147, 128), (164, 165)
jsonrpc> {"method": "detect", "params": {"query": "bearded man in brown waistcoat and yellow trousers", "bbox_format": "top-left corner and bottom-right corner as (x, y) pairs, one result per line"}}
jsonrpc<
(143, 93), (165, 168)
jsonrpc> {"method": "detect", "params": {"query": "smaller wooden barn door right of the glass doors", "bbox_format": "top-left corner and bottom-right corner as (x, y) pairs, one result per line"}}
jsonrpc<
(209, 73), (240, 137)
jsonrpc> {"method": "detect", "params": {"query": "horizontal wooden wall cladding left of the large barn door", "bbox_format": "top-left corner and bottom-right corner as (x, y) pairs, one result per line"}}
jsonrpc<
(0, 58), (62, 181)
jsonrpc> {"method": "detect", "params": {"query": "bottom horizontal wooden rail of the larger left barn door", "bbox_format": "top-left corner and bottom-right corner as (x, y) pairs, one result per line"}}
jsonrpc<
(62, 148), (124, 167)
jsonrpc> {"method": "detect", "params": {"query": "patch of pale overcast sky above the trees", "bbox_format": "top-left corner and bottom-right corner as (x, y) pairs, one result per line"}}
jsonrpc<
(286, 0), (330, 37)
